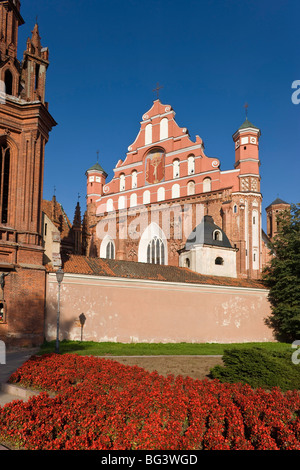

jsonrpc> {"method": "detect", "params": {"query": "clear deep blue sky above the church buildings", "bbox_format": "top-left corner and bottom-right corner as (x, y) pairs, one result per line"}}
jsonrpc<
(19, 0), (300, 225)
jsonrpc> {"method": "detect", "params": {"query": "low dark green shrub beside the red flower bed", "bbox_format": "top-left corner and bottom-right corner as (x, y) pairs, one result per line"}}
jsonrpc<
(210, 348), (300, 391)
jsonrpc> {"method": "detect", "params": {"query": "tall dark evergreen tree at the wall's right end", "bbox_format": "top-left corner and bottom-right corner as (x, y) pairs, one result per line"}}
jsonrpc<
(263, 204), (300, 342)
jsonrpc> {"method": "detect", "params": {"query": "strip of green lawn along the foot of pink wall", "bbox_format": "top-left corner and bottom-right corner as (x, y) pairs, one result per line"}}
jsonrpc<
(40, 341), (291, 356)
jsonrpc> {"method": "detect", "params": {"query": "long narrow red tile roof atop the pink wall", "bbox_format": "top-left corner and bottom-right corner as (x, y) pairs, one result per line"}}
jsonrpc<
(48, 255), (266, 289)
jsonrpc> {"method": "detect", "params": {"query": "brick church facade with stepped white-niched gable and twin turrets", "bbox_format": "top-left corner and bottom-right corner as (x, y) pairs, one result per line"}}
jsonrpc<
(86, 99), (287, 279)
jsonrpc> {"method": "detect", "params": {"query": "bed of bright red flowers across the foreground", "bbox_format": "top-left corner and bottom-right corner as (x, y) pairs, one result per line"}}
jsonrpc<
(0, 354), (300, 450)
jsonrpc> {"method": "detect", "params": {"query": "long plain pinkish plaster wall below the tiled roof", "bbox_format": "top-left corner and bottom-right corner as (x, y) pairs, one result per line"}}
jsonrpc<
(45, 273), (274, 343)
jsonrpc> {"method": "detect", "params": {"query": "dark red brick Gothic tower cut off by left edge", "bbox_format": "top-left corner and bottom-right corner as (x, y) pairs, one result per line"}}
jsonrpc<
(0, 0), (56, 344)
